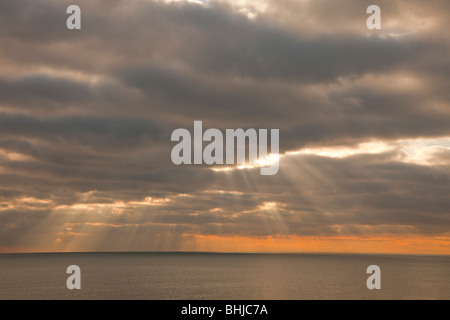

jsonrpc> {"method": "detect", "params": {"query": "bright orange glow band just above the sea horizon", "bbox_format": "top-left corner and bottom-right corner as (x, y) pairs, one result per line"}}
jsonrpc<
(0, 234), (450, 255)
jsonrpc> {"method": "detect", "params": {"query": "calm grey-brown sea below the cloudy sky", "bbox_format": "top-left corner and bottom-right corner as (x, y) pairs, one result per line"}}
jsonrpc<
(0, 253), (450, 300)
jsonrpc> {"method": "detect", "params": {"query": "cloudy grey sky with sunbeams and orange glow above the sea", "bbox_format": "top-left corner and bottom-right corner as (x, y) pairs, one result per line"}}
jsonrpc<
(0, 0), (450, 254)
